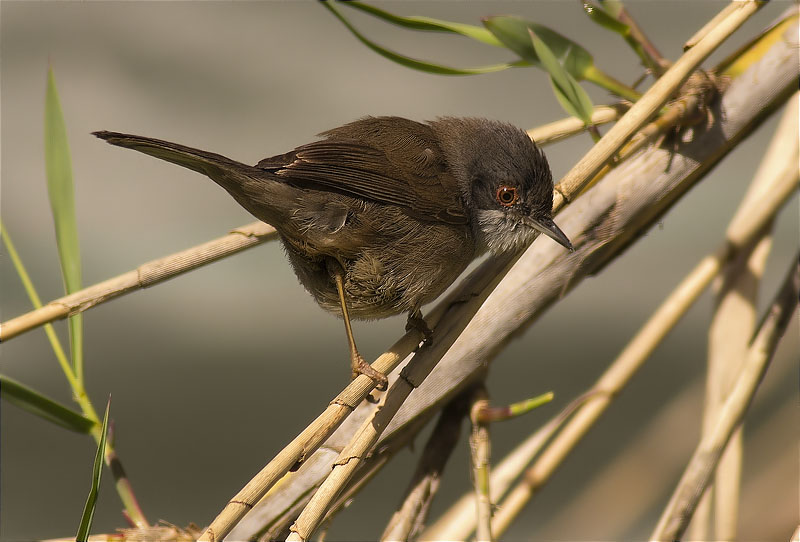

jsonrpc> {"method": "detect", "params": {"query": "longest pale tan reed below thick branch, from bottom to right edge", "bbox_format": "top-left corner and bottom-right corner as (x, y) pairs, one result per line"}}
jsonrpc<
(493, 135), (800, 536)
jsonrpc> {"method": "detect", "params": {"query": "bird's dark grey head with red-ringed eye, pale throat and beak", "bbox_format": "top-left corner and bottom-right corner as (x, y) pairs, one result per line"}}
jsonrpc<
(431, 117), (572, 254)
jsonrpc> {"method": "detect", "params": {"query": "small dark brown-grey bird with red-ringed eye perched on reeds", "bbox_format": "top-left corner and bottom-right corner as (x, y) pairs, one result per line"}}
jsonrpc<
(94, 117), (572, 389)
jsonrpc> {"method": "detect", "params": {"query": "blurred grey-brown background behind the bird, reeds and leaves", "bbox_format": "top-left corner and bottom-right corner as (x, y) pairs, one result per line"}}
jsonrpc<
(0, 1), (799, 540)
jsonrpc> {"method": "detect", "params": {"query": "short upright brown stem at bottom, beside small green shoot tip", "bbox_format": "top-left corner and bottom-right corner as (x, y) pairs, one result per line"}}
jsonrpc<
(469, 386), (493, 542)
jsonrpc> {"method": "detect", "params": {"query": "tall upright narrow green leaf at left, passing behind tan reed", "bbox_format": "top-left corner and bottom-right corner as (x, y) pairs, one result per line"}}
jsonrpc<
(44, 67), (83, 382)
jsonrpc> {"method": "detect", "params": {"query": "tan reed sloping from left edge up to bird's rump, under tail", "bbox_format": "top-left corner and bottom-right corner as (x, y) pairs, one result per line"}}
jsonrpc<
(0, 222), (277, 342)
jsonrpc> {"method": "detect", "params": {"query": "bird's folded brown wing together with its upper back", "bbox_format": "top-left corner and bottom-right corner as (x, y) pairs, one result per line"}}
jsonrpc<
(256, 117), (467, 224)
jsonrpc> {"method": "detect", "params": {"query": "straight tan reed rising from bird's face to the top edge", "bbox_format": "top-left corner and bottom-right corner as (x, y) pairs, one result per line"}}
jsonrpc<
(553, 0), (762, 209)
